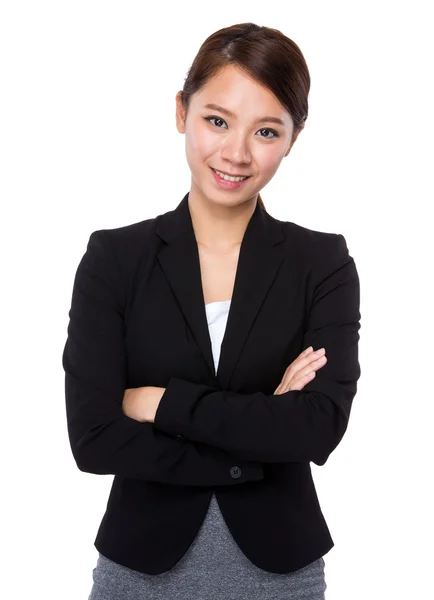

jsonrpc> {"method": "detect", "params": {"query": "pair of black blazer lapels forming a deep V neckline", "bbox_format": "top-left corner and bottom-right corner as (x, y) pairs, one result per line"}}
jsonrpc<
(157, 193), (285, 389)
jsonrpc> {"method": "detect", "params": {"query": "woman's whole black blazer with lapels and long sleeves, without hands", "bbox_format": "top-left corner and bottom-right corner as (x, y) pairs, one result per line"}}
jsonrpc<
(62, 194), (360, 574)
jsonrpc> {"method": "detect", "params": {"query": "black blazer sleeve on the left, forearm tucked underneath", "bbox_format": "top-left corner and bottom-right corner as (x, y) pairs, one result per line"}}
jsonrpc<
(62, 230), (264, 486)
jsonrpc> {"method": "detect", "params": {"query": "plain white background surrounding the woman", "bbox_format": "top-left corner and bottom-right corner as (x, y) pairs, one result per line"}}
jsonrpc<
(0, 0), (434, 600)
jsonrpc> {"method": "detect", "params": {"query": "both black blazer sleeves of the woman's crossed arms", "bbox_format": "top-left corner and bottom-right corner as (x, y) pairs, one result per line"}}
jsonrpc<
(62, 231), (360, 486)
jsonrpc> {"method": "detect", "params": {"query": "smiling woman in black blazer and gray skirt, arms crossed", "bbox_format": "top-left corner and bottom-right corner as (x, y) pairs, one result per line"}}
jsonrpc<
(63, 23), (360, 600)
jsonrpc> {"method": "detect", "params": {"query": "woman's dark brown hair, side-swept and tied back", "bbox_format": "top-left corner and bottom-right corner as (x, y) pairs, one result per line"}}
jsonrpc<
(181, 23), (310, 210)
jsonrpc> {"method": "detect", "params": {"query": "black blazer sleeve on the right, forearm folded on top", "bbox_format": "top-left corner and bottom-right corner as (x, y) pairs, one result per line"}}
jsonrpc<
(154, 234), (360, 465)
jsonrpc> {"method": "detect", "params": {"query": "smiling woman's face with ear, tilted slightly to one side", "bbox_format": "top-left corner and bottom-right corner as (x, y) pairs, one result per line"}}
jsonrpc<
(176, 65), (295, 206)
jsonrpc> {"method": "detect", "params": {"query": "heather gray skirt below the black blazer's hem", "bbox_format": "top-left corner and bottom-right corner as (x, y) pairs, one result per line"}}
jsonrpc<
(88, 495), (327, 600)
